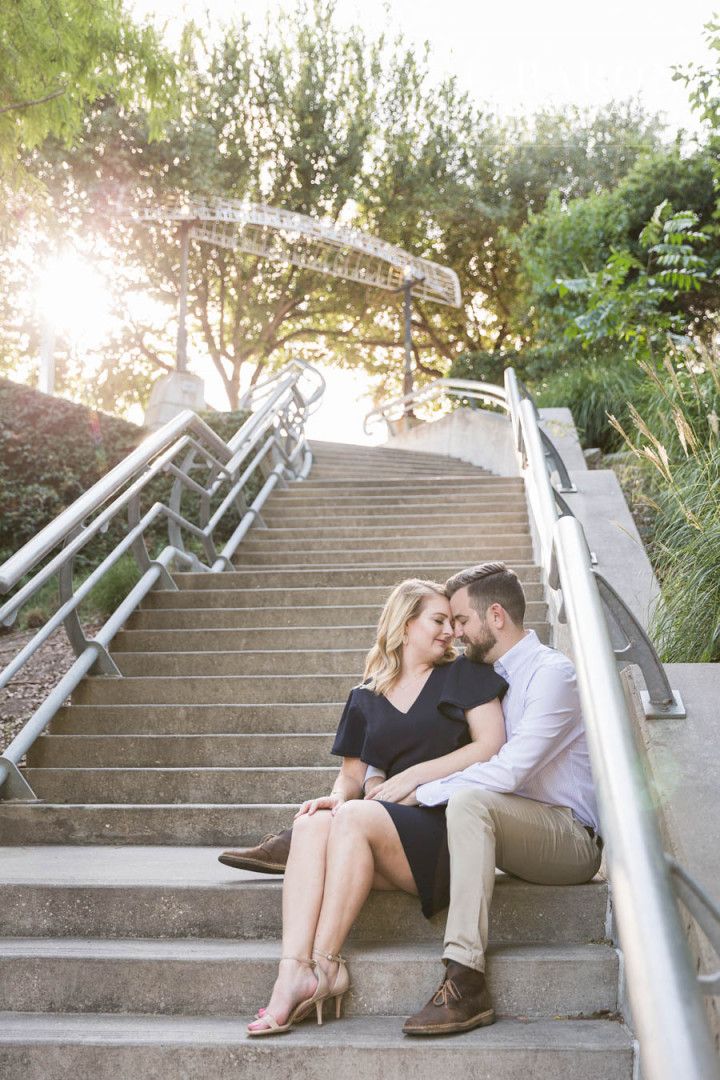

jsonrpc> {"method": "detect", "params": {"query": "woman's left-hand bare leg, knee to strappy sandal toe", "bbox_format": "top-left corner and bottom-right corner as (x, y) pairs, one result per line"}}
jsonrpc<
(249, 810), (332, 1030)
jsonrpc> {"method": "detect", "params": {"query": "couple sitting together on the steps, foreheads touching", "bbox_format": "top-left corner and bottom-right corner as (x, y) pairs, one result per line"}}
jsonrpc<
(220, 563), (602, 1037)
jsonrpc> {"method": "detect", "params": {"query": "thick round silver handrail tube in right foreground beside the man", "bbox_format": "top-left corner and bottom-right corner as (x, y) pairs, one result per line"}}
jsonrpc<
(553, 517), (718, 1080)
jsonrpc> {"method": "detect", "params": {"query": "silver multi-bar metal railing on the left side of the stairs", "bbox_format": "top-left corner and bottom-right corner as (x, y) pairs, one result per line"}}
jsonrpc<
(0, 361), (325, 799)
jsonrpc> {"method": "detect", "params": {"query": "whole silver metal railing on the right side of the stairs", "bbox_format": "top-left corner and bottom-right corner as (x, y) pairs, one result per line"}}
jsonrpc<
(368, 368), (720, 1080)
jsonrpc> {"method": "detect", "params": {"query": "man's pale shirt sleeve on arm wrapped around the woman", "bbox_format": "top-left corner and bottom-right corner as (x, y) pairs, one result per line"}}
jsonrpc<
(416, 665), (580, 807)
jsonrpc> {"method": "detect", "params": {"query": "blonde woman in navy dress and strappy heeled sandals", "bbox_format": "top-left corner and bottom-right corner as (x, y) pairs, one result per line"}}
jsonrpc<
(247, 578), (507, 1036)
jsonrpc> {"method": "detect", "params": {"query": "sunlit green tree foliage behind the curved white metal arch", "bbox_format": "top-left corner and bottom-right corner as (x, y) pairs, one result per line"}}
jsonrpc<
(12, 0), (657, 402)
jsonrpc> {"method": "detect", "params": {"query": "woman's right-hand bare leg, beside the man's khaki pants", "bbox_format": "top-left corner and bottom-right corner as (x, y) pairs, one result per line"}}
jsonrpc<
(314, 800), (418, 986)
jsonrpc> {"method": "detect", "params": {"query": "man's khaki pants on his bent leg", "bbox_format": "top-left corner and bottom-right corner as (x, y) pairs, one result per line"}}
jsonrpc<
(443, 787), (601, 971)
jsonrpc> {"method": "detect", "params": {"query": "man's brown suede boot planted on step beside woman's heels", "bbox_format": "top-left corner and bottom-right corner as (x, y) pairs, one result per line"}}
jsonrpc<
(403, 960), (495, 1035)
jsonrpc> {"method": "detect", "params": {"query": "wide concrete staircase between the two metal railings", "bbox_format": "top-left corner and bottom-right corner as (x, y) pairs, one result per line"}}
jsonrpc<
(0, 443), (633, 1080)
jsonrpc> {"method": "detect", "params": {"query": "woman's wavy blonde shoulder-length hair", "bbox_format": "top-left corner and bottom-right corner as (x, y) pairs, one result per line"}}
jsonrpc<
(363, 578), (456, 693)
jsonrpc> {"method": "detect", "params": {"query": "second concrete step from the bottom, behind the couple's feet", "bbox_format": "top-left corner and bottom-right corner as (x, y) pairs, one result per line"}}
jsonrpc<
(0, 937), (617, 1018)
